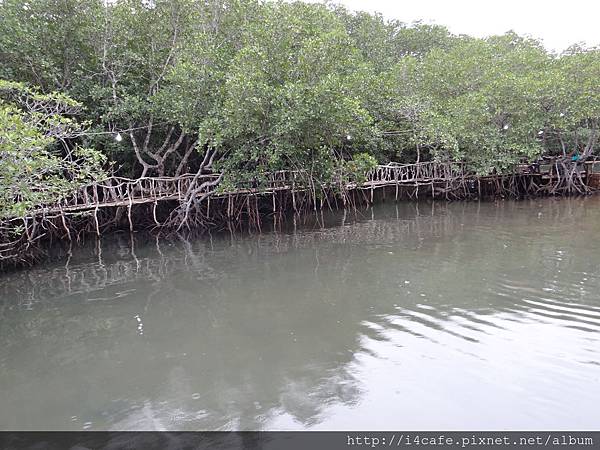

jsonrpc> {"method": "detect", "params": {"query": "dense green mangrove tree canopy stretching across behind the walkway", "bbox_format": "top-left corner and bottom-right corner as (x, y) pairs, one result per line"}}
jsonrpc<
(0, 0), (600, 219)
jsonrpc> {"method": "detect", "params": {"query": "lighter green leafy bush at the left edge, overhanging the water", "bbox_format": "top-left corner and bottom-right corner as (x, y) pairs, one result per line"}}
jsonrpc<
(0, 80), (105, 218)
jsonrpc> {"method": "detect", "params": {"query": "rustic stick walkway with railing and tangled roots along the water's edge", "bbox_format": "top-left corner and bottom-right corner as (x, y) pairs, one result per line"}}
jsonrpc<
(0, 159), (600, 268)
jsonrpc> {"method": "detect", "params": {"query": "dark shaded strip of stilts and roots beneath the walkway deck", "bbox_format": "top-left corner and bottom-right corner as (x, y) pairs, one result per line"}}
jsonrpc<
(0, 174), (598, 274)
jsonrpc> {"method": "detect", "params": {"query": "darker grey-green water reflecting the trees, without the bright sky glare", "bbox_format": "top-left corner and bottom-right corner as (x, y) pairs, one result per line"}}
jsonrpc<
(0, 199), (600, 430)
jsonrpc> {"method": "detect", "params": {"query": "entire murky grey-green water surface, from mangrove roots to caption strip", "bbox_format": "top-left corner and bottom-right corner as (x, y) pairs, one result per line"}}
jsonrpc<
(0, 198), (600, 430)
